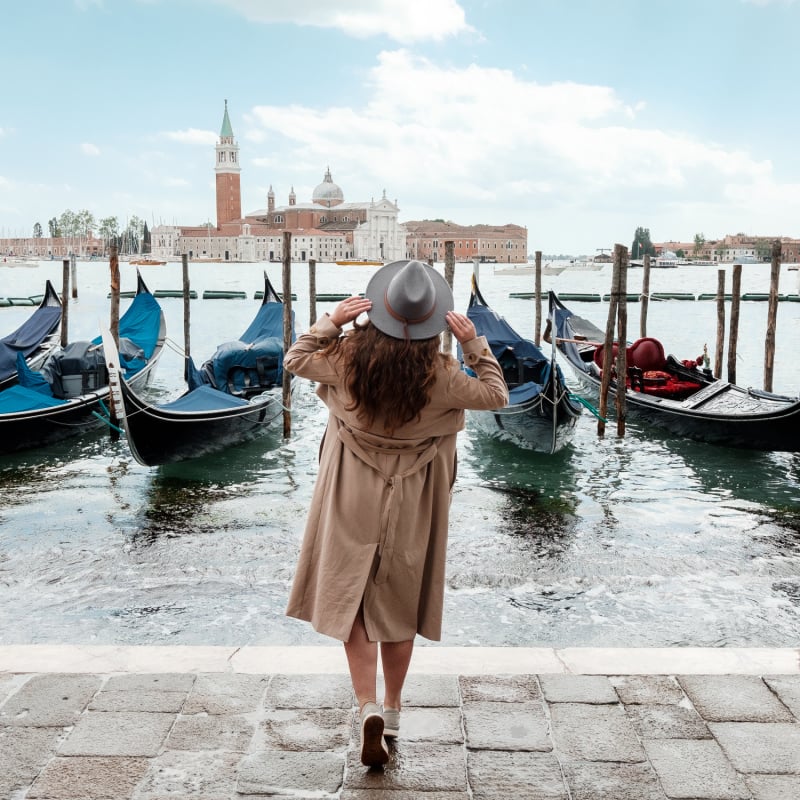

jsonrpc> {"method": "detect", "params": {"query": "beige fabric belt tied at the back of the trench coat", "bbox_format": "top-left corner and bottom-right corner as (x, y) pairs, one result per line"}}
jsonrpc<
(338, 425), (439, 583)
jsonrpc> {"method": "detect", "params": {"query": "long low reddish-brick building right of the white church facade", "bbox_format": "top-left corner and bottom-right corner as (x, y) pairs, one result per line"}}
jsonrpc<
(405, 220), (528, 264)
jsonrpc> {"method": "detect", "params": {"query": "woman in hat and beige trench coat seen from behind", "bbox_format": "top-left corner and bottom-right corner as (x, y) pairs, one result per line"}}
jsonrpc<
(284, 261), (508, 766)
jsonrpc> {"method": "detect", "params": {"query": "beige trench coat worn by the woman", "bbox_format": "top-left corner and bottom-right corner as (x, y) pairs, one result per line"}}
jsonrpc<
(284, 315), (508, 642)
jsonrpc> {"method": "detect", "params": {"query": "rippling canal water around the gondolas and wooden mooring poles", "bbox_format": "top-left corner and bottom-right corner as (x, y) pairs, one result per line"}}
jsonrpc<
(0, 262), (800, 647)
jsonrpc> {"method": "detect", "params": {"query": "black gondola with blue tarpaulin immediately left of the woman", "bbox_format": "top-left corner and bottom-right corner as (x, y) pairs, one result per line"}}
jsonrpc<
(106, 274), (294, 467)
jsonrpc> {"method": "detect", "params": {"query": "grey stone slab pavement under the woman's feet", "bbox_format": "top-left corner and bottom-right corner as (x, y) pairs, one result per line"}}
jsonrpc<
(0, 648), (800, 800)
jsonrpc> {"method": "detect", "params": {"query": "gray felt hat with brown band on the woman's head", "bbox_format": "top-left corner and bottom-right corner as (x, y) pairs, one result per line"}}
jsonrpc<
(364, 261), (453, 339)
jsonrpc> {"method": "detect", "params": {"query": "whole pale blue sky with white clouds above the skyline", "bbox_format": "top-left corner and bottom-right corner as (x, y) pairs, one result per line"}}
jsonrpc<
(0, 0), (800, 255)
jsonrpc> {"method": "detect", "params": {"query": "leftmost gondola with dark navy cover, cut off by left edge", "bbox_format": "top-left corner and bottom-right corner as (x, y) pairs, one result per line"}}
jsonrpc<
(0, 281), (61, 391)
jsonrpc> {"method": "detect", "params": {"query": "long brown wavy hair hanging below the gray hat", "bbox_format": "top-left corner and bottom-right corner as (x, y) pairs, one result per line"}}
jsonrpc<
(327, 322), (448, 436)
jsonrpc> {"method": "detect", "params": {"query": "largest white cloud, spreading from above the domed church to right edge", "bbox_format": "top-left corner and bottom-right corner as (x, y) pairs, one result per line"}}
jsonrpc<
(246, 50), (800, 244)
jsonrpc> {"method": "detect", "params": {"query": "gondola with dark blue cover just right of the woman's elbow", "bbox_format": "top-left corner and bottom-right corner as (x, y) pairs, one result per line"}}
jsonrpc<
(458, 277), (582, 453)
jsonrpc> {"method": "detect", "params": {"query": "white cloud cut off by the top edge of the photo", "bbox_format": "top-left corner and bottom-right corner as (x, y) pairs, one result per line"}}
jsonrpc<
(208, 0), (473, 43)
